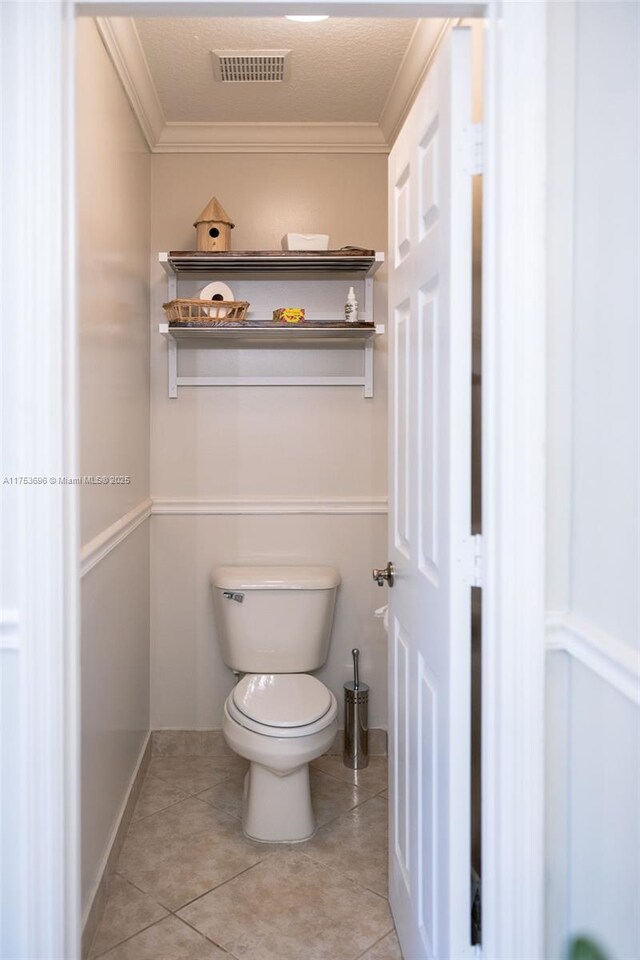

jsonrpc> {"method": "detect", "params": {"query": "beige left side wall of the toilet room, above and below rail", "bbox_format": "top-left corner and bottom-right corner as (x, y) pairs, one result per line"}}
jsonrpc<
(77, 20), (150, 910)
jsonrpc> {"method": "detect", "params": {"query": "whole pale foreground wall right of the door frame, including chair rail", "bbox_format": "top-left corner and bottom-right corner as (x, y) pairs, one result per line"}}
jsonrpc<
(546, 0), (640, 958)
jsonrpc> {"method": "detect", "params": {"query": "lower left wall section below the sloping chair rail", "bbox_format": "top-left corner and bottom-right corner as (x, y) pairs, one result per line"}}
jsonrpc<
(82, 521), (149, 910)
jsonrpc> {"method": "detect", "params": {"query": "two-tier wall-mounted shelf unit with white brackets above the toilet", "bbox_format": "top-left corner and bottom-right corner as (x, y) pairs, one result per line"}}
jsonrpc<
(158, 248), (384, 398)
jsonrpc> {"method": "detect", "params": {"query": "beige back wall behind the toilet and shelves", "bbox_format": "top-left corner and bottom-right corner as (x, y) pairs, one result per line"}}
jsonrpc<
(151, 154), (387, 728)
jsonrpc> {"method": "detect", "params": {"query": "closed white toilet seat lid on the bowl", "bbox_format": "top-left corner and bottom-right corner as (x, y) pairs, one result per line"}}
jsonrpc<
(226, 673), (338, 738)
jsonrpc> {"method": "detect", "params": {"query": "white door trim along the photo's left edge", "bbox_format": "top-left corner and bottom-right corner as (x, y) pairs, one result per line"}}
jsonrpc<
(0, 0), (80, 960)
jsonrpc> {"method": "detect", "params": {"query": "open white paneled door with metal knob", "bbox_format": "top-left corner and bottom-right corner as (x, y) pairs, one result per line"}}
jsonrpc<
(389, 29), (476, 960)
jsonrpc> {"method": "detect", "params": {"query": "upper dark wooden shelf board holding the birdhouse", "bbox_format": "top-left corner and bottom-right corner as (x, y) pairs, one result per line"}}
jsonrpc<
(158, 249), (384, 280)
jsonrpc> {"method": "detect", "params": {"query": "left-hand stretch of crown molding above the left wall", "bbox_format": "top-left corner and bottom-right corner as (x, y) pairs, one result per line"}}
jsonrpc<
(96, 17), (166, 151)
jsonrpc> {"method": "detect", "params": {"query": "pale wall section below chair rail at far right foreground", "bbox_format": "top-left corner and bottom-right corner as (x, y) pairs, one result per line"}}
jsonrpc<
(568, 660), (640, 958)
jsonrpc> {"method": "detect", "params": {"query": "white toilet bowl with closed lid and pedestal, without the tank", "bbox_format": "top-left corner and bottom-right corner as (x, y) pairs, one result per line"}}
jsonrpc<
(222, 674), (338, 843)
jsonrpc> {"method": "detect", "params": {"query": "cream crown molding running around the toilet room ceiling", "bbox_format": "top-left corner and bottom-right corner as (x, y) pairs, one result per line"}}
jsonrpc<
(96, 17), (450, 154)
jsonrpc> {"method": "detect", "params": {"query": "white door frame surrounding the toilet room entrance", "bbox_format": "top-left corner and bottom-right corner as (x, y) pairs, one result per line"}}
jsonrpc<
(0, 0), (546, 960)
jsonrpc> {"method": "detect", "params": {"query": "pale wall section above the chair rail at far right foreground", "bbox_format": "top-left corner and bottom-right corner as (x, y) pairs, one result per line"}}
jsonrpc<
(571, 2), (640, 648)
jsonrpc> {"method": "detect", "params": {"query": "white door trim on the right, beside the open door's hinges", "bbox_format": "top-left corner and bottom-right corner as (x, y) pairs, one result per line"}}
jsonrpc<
(482, 0), (546, 960)
